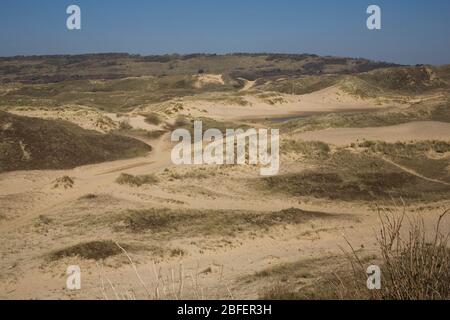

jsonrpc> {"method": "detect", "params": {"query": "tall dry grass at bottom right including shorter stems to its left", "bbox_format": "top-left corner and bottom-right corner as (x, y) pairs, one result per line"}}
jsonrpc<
(337, 207), (450, 300)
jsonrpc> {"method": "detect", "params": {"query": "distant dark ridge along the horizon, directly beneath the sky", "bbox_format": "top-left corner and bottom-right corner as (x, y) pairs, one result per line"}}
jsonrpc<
(0, 53), (393, 83)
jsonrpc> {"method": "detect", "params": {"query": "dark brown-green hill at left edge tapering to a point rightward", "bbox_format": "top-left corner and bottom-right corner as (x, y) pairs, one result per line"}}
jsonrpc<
(0, 111), (151, 172)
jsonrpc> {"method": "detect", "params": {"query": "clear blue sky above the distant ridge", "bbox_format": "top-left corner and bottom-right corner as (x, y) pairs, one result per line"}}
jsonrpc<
(0, 0), (450, 64)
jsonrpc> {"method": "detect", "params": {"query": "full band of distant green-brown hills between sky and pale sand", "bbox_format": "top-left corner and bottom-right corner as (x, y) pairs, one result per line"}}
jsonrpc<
(0, 54), (450, 112)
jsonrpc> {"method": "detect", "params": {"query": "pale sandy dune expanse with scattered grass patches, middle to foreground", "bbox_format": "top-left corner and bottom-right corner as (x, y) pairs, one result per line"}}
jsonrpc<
(0, 57), (450, 299)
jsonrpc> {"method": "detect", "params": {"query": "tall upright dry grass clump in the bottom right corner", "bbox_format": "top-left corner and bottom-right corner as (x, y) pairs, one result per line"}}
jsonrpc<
(379, 206), (450, 300)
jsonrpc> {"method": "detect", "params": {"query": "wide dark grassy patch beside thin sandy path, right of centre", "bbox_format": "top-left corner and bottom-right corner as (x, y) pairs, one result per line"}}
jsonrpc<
(264, 146), (450, 202)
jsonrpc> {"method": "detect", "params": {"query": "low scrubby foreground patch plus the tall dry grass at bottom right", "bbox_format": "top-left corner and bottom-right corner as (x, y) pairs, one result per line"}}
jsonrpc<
(251, 211), (450, 300)
